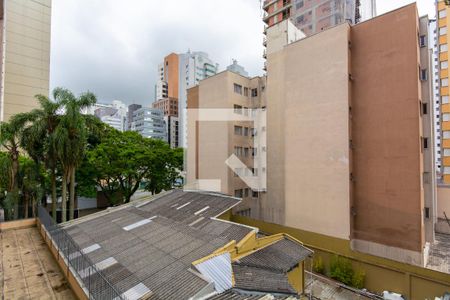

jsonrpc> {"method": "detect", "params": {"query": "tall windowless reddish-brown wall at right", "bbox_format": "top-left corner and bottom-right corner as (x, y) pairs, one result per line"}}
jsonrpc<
(351, 4), (431, 254)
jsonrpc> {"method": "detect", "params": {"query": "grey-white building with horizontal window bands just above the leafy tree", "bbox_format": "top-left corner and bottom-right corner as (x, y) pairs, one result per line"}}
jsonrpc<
(131, 107), (166, 140)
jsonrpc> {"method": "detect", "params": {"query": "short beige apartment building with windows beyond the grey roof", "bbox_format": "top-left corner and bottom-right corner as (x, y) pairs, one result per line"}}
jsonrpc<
(186, 71), (265, 205)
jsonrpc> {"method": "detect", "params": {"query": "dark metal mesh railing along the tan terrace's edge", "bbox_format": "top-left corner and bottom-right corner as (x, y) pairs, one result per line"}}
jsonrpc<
(38, 206), (126, 300)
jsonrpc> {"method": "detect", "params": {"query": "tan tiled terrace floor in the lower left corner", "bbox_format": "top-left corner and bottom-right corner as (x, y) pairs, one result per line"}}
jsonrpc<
(0, 227), (76, 299)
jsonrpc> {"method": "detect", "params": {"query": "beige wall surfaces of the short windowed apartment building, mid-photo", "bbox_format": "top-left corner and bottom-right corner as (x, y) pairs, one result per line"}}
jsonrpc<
(187, 71), (261, 201)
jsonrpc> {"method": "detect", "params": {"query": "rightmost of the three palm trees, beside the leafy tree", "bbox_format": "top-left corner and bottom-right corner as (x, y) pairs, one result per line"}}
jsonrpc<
(53, 88), (97, 222)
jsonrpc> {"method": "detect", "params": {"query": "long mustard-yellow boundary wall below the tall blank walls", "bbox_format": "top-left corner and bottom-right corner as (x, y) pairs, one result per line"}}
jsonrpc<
(232, 216), (450, 299)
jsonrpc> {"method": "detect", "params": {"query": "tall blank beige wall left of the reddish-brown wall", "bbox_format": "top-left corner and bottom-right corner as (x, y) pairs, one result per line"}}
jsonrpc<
(263, 24), (350, 240)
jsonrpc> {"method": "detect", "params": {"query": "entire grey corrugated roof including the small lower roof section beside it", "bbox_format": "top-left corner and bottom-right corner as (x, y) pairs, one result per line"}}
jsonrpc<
(60, 190), (312, 299)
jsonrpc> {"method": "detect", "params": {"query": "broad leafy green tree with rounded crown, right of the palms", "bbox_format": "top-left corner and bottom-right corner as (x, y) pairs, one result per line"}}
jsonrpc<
(88, 131), (179, 205)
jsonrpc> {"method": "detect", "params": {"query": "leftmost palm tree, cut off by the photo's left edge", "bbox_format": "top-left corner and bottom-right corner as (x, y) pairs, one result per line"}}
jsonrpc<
(0, 113), (27, 218)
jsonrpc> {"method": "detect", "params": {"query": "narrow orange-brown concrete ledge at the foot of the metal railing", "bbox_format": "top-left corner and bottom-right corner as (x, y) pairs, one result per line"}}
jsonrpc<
(35, 220), (89, 300)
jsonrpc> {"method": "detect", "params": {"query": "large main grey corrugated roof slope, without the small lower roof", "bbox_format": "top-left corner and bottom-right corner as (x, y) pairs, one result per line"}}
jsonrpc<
(65, 191), (253, 299)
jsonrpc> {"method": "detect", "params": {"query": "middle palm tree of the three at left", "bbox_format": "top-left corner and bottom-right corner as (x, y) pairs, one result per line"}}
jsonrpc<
(20, 95), (62, 220)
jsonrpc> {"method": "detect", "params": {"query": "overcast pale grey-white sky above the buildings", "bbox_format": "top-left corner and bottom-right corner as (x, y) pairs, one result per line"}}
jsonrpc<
(50, 0), (435, 106)
